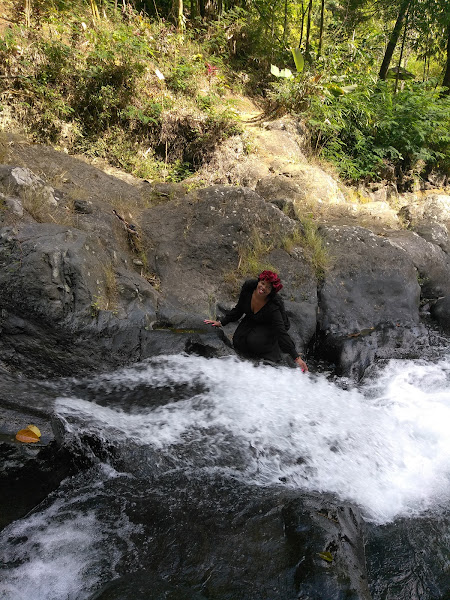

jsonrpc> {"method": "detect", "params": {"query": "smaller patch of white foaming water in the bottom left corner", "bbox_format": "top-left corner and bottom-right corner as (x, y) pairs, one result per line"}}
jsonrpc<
(0, 465), (140, 600)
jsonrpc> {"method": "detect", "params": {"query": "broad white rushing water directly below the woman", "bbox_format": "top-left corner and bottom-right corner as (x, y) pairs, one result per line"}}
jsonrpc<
(58, 356), (450, 522)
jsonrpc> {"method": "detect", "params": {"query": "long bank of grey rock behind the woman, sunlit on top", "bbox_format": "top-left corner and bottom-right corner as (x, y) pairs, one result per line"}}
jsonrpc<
(0, 150), (450, 378)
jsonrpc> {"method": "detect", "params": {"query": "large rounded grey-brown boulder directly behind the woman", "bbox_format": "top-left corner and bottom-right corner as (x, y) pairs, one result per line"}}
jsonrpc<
(141, 186), (317, 350)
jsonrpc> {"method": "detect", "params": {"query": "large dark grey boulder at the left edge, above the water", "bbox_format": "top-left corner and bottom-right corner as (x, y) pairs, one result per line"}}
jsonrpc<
(0, 223), (232, 376)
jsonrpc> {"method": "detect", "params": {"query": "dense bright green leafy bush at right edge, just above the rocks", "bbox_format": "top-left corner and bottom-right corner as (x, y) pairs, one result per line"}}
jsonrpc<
(308, 82), (450, 181)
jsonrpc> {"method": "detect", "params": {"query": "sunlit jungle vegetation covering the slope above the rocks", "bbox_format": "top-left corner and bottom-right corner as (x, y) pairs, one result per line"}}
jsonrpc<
(0, 0), (450, 182)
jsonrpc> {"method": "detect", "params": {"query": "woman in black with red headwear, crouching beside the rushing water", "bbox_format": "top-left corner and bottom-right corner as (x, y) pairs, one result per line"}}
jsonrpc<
(204, 271), (308, 371)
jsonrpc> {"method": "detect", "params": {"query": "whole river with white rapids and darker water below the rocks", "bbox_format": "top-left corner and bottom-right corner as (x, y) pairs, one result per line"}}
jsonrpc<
(0, 355), (450, 600)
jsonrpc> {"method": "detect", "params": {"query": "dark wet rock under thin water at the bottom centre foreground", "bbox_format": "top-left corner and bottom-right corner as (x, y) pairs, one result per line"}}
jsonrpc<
(87, 473), (371, 600)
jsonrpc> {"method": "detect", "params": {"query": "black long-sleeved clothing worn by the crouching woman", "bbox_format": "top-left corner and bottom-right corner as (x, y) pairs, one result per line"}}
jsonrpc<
(220, 279), (299, 362)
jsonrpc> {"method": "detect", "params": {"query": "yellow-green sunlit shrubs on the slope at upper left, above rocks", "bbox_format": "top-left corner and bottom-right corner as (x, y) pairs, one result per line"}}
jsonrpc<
(0, 4), (243, 181)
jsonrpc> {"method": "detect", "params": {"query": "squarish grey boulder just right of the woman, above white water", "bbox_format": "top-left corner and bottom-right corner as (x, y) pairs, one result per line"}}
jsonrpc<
(318, 226), (425, 378)
